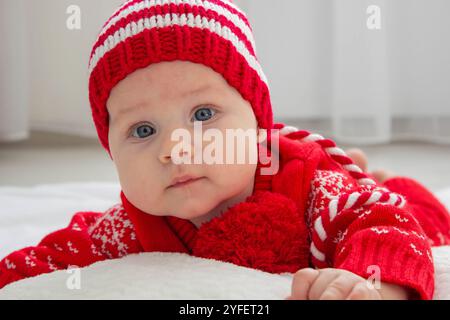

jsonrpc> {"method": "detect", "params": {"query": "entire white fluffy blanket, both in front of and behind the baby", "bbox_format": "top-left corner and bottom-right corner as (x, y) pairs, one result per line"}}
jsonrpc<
(0, 183), (450, 300)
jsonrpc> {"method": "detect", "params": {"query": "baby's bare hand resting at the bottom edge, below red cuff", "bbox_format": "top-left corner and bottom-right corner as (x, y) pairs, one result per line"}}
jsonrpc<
(287, 268), (408, 300)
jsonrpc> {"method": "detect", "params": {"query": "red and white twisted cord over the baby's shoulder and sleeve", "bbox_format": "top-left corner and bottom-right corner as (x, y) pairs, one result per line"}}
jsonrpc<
(274, 123), (406, 268)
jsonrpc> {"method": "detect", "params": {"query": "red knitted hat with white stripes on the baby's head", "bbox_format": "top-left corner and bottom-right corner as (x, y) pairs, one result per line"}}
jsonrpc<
(89, 0), (273, 152)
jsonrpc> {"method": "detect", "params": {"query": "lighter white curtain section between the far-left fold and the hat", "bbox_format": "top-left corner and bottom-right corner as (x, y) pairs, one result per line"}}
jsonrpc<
(25, 0), (124, 137)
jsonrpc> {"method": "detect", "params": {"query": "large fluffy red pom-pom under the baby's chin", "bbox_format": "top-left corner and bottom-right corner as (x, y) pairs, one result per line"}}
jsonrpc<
(193, 191), (309, 273)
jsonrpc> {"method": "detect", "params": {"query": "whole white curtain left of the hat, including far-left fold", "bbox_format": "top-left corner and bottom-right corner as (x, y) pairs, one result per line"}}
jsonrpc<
(0, 0), (124, 141)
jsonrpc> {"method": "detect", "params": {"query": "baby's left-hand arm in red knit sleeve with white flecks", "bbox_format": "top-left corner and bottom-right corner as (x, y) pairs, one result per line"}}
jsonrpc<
(0, 205), (142, 288)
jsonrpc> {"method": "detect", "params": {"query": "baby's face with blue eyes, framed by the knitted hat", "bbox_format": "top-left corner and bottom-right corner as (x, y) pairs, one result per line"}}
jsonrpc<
(107, 61), (257, 219)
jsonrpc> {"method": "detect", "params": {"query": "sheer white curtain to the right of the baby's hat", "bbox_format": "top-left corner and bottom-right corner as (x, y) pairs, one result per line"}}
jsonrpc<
(241, 0), (450, 144)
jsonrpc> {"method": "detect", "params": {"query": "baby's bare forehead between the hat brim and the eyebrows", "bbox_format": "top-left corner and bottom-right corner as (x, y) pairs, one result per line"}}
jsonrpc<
(107, 61), (240, 117)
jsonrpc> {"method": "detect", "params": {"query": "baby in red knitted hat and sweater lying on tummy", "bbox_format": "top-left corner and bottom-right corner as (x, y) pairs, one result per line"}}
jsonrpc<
(0, 0), (450, 299)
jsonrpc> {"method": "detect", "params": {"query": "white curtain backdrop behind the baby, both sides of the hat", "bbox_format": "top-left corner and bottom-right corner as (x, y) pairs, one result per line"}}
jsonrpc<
(0, 0), (450, 143)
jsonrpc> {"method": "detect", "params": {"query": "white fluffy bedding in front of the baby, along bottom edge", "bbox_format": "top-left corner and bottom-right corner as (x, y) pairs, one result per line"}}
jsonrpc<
(0, 246), (450, 300)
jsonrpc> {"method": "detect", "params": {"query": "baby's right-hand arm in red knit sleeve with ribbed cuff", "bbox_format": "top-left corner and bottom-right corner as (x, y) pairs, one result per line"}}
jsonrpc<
(293, 170), (434, 299)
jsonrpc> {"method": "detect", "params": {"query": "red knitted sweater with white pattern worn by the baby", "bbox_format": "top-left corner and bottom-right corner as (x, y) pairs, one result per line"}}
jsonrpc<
(0, 137), (450, 299)
